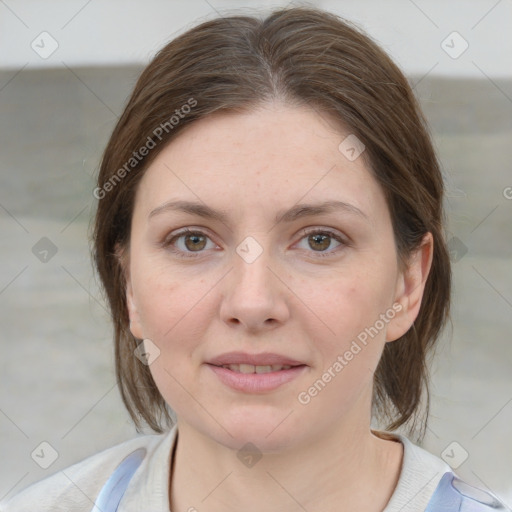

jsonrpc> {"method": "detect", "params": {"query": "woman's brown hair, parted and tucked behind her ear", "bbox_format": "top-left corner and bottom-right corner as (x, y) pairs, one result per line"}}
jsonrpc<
(93, 7), (451, 433)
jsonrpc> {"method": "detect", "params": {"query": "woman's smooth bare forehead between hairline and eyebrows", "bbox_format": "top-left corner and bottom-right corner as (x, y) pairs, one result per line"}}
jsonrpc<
(136, 104), (387, 224)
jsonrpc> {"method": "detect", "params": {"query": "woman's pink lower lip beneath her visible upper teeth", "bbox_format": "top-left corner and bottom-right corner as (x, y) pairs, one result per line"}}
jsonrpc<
(207, 364), (307, 393)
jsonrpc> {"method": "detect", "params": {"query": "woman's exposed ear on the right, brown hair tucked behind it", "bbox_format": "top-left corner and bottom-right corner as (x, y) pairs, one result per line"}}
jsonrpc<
(386, 232), (434, 341)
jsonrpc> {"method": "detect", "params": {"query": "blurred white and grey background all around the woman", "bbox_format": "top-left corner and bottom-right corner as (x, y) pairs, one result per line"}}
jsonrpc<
(0, 0), (512, 506)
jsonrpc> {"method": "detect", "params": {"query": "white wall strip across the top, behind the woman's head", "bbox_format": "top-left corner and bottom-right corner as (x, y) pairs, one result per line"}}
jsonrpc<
(0, 0), (512, 77)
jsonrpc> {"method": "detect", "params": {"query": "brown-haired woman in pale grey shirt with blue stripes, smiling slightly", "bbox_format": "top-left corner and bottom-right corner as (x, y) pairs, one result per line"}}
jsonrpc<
(1, 8), (505, 512)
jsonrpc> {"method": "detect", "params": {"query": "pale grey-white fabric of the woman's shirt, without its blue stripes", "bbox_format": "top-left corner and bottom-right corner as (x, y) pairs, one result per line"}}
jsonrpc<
(0, 425), (451, 512)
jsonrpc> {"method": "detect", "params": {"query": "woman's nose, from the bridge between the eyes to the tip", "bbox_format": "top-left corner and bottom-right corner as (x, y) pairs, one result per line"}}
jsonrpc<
(221, 236), (288, 329)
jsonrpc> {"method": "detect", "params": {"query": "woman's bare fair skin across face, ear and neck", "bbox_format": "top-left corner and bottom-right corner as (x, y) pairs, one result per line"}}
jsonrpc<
(121, 103), (433, 512)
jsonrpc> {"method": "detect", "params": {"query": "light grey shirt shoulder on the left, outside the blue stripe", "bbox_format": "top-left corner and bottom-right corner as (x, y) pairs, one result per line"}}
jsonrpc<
(0, 434), (168, 512)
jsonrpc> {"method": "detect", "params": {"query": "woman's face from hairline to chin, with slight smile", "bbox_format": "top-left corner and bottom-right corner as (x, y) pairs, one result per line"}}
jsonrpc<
(124, 104), (430, 452)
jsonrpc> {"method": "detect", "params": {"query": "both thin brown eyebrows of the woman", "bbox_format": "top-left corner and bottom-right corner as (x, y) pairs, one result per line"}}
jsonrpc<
(148, 201), (369, 224)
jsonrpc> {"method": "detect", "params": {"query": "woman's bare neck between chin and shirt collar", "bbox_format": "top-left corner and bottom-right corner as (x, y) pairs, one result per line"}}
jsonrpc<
(170, 412), (402, 512)
